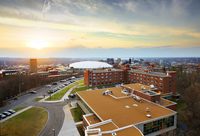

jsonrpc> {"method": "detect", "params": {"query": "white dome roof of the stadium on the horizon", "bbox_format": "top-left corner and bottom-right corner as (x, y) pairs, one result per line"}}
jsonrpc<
(69, 61), (112, 69)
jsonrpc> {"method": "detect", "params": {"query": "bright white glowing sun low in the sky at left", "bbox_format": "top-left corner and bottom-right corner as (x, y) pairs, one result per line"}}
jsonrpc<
(28, 40), (48, 50)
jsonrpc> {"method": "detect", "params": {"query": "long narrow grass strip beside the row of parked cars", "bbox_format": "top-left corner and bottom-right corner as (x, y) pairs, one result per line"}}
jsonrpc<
(46, 80), (83, 101)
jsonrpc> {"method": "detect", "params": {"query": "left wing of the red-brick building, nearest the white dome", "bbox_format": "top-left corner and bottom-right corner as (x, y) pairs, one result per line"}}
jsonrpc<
(84, 69), (125, 86)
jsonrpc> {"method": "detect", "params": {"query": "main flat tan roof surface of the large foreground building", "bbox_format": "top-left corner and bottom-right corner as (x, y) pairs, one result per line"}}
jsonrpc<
(77, 87), (176, 127)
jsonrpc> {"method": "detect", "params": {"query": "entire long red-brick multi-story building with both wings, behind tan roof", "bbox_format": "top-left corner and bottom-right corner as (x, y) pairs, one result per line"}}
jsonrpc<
(84, 69), (176, 94)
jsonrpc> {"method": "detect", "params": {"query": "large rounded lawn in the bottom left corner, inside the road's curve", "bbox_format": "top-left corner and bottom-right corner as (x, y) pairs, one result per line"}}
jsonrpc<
(0, 107), (48, 136)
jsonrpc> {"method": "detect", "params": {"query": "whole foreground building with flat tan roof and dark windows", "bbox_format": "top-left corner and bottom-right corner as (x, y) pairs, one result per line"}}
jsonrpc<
(77, 84), (177, 136)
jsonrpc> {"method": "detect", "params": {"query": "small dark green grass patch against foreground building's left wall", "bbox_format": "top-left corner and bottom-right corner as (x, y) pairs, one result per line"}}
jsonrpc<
(70, 106), (83, 122)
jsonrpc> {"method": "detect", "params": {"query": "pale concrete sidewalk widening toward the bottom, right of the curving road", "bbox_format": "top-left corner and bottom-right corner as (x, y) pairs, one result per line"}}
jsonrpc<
(58, 105), (80, 136)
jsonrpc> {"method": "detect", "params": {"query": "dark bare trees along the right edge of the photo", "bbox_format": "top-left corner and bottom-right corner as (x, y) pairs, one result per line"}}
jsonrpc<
(177, 69), (200, 136)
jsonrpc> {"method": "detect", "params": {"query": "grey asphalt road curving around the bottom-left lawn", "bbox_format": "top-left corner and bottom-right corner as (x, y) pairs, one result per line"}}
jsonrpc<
(0, 79), (76, 136)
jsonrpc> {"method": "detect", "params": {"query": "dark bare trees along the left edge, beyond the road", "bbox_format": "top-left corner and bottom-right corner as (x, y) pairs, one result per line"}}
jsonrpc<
(0, 75), (78, 106)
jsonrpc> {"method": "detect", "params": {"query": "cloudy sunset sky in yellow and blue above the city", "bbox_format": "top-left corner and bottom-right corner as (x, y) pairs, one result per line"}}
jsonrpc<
(0, 0), (200, 58)
